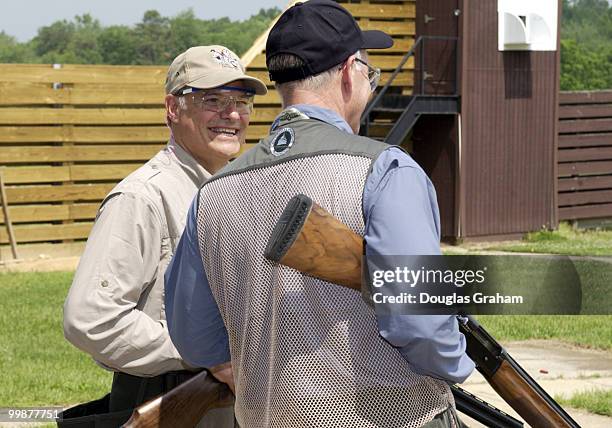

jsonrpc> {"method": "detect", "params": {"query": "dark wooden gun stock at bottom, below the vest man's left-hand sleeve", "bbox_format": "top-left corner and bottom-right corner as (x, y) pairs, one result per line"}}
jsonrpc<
(123, 371), (234, 428)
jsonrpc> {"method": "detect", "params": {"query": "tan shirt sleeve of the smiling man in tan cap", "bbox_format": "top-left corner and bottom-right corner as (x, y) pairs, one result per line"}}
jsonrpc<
(64, 193), (185, 376)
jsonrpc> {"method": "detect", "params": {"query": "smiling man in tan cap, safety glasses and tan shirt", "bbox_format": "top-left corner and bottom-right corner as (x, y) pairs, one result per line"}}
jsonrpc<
(60, 46), (267, 427)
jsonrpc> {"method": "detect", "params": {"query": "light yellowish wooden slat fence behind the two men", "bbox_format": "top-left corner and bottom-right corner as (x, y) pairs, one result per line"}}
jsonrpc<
(0, 0), (415, 259)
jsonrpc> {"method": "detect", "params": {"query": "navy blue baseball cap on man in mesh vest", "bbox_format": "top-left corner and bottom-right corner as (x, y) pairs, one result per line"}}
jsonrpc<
(266, 0), (393, 83)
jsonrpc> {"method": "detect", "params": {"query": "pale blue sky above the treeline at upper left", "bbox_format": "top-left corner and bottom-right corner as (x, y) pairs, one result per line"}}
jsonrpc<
(0, 0), (289, 42)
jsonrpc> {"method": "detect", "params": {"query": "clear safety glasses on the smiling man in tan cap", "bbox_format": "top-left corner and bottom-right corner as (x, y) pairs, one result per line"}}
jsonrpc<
(183, 86), (255, 115)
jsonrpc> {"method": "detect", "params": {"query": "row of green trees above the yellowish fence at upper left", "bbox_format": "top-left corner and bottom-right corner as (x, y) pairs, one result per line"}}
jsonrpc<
(0, 8), (280, 65)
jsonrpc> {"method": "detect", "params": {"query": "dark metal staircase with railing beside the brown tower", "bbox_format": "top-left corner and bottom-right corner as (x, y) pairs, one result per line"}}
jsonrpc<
(360, 36), (459, 145)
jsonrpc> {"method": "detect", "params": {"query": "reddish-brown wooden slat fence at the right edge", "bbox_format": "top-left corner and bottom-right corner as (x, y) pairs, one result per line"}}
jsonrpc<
(557, 91), (612, 220)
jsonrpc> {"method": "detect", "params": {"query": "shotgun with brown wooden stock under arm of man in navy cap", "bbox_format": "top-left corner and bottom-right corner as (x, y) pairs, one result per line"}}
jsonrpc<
(265, 194), (580, 428)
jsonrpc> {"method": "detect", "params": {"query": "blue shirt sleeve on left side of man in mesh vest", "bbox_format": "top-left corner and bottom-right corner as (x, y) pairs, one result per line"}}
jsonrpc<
(165, 196), (230, 368)
